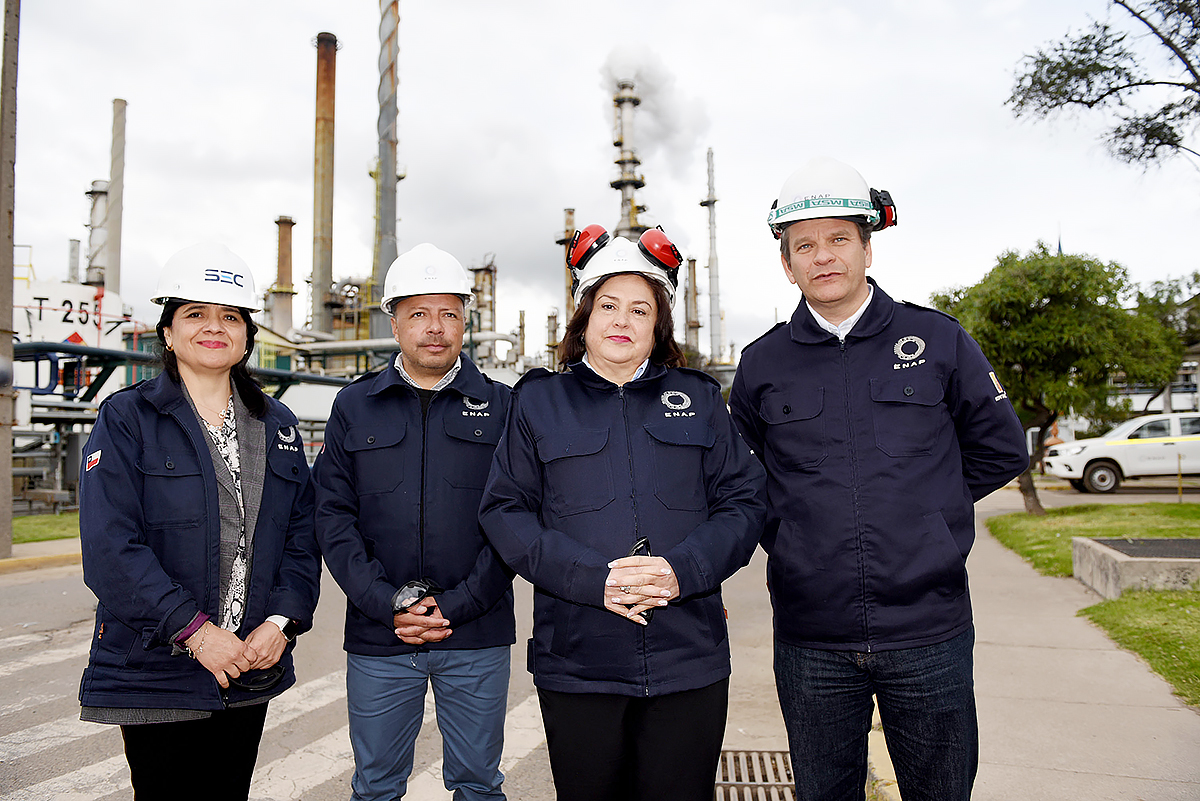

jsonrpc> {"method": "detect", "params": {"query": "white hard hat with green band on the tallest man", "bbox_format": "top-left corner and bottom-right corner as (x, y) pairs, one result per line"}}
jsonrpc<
(767, 158), (896, 239)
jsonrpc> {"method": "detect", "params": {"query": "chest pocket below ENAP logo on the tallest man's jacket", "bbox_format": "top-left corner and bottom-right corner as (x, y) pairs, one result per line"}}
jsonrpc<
(871, 374), (950, 457)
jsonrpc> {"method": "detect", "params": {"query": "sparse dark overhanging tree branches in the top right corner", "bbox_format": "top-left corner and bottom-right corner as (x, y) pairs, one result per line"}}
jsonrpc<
(1008, 0), (1200, 165)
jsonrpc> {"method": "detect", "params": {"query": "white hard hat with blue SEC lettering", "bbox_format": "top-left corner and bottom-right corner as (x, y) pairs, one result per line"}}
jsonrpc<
(150, 242), (263, 312)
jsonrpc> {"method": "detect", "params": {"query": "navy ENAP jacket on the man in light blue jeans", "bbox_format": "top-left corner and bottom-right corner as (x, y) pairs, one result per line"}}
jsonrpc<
(313, 354), (516, 656)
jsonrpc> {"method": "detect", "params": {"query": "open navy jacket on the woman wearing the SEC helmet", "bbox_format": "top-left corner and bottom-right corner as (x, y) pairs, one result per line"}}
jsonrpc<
(79, 374), (320, 710)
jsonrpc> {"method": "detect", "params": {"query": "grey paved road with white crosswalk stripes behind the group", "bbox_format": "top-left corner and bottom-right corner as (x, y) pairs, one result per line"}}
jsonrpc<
(0, 544), (786, 801)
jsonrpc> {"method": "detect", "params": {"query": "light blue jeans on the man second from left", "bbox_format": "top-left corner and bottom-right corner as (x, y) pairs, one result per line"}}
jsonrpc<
(346, 645), (510, 801)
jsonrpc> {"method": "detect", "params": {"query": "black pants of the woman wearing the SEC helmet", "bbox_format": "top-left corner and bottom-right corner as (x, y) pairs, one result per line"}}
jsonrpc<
(121, 703), (266, 801)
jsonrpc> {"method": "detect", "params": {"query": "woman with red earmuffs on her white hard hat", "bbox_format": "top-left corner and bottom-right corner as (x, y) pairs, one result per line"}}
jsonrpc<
(480, 225), (764, 801)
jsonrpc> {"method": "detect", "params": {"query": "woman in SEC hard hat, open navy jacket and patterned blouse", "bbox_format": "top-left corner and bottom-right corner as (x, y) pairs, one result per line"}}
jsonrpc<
(79, 245), (320, 801)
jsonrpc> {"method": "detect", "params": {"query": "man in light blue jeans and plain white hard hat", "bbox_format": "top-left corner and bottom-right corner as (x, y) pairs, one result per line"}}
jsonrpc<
(313, 245), (516, 801)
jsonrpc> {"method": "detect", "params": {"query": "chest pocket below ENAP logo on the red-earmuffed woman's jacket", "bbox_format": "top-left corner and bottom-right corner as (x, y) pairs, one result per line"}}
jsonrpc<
(646, 418), (716, 512)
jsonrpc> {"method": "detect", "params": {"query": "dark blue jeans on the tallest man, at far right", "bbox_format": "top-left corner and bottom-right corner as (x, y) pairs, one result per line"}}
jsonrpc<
(775, 630), (979, 801)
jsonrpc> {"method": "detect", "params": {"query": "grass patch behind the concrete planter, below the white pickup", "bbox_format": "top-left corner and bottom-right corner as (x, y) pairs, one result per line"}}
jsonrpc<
(988, 504), (1200, 576)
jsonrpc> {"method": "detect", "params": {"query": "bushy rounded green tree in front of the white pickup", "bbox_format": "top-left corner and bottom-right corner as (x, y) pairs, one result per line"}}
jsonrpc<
(934, 242), (1178, 514)
